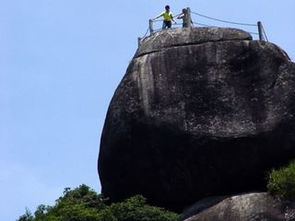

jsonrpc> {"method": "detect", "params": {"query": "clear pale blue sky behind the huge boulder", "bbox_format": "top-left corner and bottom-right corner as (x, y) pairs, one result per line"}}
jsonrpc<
(0, 0), (295, 221)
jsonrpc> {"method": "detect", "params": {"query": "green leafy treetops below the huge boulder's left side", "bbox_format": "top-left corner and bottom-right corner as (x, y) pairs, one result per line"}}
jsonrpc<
(17, 184), (179, 221)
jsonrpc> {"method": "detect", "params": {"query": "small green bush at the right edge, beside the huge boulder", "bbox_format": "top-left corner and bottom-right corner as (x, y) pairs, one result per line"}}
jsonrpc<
(267, 161), (295, 199)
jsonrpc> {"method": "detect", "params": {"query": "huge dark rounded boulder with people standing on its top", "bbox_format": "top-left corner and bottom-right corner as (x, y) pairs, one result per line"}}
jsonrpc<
(98, 28), (295, 209)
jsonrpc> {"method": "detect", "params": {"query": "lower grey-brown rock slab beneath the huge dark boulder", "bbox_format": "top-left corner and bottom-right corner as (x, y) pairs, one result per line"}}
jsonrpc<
(185, 193), (295, 221)
